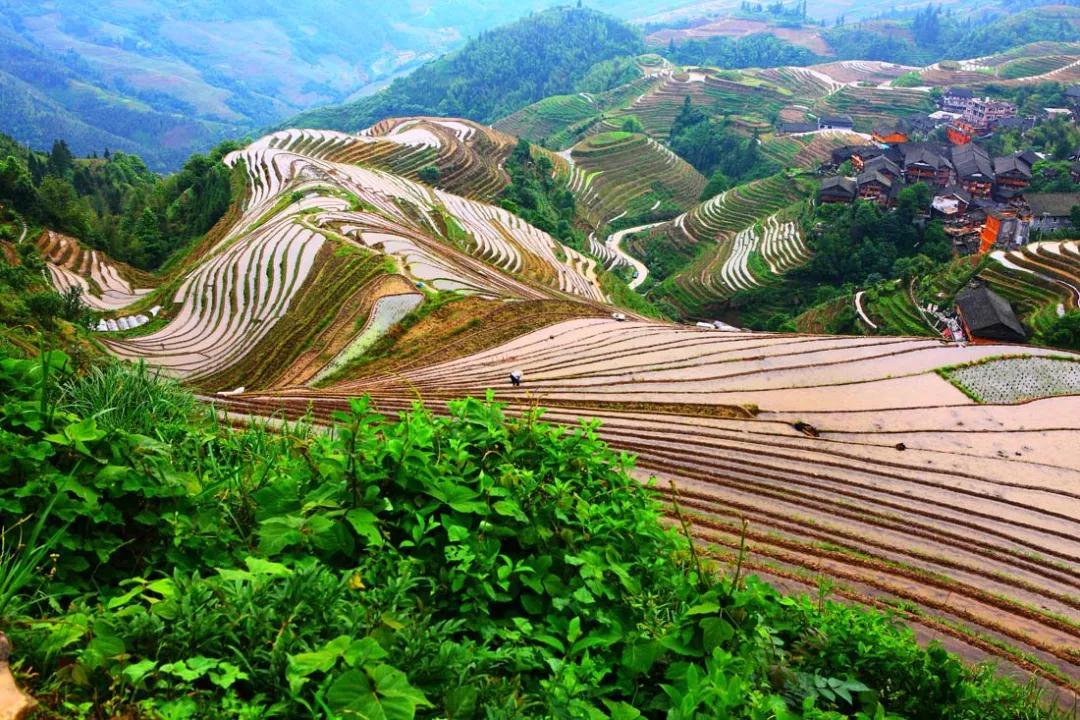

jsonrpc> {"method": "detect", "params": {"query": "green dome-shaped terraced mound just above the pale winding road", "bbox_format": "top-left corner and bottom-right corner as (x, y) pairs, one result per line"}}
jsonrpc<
(568, 133), (705, 228)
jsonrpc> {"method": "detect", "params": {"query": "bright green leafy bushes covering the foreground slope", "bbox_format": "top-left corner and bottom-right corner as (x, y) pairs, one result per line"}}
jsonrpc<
(0, 353), (1053, 720)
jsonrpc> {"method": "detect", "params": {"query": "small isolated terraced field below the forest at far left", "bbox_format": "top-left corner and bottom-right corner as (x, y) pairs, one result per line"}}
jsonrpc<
(38, 230), (150, 312)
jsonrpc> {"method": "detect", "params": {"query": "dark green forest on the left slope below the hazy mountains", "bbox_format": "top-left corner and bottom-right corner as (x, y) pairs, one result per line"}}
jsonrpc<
(0, 136), (235, 270)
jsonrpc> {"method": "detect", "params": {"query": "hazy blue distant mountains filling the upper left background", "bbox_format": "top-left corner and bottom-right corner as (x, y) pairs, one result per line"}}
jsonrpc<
(0, 0), (687, 167)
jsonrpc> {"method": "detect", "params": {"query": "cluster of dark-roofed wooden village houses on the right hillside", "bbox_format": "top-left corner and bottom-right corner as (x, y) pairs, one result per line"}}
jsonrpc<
(819, 142), (1080, 255)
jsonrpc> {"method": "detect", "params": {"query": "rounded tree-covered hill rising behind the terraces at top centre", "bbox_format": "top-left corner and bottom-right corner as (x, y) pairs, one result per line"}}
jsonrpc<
(288, 8), (644, 131)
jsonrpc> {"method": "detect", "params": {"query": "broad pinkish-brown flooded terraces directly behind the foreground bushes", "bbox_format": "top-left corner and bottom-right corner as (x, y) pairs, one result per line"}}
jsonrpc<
(217, 318), (1080, 696)
